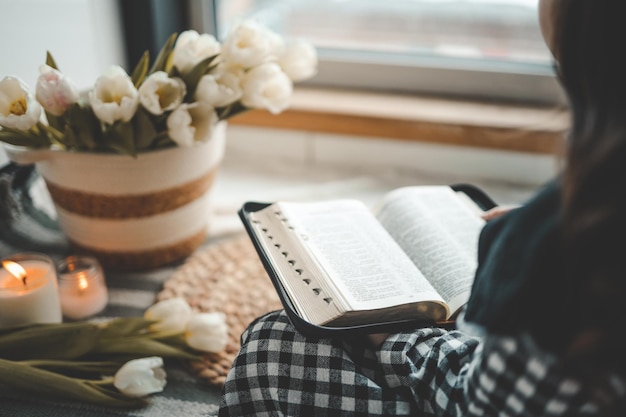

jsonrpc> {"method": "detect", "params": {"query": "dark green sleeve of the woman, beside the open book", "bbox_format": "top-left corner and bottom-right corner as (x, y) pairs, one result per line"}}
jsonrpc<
(465, 181), (567, 350)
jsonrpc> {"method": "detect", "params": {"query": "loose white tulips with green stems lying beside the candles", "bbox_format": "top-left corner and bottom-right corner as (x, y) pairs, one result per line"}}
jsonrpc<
(0, 298), (228, 407)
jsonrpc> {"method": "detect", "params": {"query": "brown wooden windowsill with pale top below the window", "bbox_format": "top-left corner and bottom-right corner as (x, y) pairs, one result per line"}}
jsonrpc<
(229, 86), (569, 154)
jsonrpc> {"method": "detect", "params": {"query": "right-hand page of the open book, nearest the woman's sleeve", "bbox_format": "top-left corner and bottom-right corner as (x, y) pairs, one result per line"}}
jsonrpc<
(375, 186), (485, 311)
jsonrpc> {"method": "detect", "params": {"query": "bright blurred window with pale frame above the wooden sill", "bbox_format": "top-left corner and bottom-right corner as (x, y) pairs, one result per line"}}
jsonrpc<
(191, 0), (564, 104)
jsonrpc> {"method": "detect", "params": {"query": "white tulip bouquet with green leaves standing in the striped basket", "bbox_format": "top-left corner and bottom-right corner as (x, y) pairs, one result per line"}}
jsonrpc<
(0, 20), (317, 155)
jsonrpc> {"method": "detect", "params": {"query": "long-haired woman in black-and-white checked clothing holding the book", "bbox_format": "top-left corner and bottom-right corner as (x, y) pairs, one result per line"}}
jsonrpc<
(220, 0), (626, 416)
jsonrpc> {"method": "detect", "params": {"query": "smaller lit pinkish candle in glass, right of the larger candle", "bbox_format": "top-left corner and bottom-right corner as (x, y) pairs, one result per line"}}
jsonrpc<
(58, 256), (109, 320)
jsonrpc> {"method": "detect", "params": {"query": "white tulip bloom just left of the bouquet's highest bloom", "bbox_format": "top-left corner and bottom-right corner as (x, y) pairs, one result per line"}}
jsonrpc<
(172, 30), (221, 74)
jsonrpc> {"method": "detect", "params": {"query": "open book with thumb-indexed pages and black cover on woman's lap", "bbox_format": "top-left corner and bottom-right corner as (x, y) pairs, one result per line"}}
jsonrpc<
(239, 184), (495, 335)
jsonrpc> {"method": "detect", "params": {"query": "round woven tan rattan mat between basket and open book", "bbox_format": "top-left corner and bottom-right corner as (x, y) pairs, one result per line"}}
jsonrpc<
(157, 235), (281, 387)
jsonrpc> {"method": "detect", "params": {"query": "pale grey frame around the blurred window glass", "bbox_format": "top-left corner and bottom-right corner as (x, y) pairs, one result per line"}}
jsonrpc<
(188, 0), (566, 106)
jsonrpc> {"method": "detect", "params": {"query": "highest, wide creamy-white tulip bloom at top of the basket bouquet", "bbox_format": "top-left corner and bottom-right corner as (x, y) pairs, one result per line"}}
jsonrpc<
(222, 20), (285, 68)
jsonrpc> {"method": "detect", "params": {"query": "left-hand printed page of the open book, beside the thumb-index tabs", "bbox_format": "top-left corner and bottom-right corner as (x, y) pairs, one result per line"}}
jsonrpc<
(278, 200), (441, 310)
